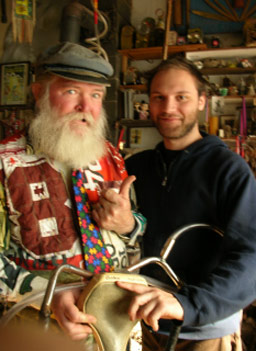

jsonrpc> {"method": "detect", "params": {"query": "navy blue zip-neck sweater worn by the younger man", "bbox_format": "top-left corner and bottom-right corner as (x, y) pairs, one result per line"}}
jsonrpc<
(126, 134), (256, 338)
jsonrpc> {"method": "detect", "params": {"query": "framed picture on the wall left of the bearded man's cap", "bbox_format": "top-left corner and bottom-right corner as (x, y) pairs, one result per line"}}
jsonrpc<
(0, 62), (30, 106)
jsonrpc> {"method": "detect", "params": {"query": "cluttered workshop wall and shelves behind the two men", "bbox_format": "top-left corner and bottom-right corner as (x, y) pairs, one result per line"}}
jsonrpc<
(0, 0), (256, 351)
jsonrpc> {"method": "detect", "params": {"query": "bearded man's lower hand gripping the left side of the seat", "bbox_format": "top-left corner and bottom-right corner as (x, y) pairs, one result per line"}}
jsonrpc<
(51, 288), (96, 340)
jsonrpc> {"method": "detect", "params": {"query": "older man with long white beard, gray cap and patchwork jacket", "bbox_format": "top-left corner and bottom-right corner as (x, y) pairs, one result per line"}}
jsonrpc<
(0, 43), (143, 339)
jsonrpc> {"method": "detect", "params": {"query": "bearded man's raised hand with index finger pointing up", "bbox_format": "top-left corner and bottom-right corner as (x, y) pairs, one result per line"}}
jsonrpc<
(92, 176), (136, 234)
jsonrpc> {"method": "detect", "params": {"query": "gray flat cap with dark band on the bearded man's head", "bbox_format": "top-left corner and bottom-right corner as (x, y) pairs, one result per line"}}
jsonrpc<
(37, 42), (114, 86)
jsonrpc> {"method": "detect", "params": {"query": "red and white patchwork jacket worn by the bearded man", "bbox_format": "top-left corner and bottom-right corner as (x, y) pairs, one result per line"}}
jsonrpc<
(0, 137), (143, 300)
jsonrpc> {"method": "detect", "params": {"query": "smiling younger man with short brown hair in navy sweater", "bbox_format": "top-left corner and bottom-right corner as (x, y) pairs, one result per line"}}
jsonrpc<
(118, 57), (256, 351)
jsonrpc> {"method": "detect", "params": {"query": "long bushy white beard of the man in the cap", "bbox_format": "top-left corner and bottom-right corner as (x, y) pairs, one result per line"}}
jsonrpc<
(29, 91), (107, 168)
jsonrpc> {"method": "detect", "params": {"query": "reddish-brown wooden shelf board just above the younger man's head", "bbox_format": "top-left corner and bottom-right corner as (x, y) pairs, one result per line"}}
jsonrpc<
(118, 44), (207, 60)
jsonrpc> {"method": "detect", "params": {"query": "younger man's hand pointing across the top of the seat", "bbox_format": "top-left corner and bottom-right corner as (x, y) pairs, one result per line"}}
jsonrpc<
(116, 281), (184, 331)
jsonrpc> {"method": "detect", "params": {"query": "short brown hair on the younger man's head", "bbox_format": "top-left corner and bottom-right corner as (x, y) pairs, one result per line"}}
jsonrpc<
(144, 55), (209, 96)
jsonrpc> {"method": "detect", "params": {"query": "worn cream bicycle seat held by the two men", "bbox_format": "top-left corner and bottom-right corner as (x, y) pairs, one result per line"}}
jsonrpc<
(78, 273), (147, 351)
